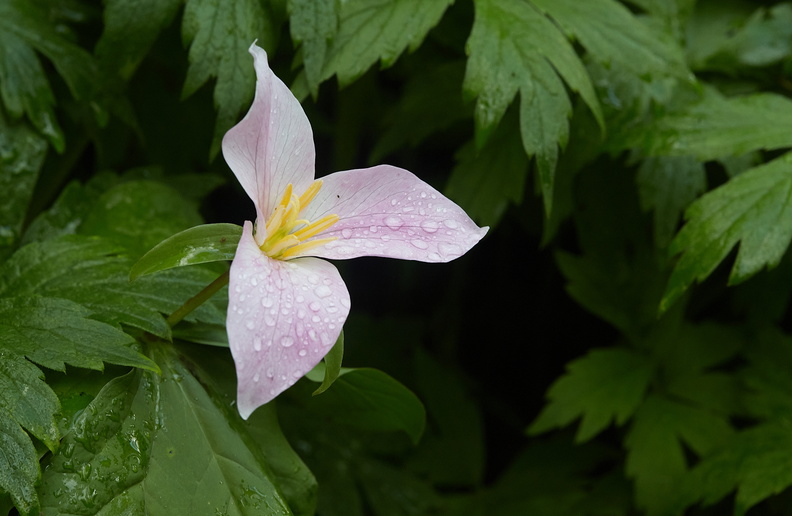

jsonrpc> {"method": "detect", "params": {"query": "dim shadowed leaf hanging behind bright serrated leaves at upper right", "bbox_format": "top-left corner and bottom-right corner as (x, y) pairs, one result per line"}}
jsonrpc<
(636, 156), (707, 248)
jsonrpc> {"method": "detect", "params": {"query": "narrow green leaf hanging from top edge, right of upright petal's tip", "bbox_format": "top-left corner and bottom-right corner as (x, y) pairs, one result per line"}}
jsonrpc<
(288, 0), (338, 97)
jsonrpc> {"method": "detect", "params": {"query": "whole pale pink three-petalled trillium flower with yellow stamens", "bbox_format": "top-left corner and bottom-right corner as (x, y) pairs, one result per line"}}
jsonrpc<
(223, 43), (488, 419)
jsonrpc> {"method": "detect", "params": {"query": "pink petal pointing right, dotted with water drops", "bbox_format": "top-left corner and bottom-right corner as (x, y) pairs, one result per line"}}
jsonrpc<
(296, 165), (489, 262)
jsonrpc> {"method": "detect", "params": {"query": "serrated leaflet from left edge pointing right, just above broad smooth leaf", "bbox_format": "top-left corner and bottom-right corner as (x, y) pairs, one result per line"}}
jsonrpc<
(0, 296), (157, 371)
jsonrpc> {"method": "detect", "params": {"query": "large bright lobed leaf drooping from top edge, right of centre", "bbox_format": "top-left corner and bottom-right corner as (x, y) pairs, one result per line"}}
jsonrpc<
(463, 0), (603, 213)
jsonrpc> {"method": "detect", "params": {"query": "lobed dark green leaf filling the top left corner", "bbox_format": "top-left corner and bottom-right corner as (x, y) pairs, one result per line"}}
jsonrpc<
(0, 0), (98, 152)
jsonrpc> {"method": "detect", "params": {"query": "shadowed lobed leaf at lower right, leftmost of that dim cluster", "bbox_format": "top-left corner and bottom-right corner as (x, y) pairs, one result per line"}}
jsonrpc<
(528, 348), (653, 442)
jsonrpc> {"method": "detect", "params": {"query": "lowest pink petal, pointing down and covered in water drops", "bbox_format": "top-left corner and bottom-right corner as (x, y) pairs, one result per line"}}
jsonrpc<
(227, 222), (349, 419)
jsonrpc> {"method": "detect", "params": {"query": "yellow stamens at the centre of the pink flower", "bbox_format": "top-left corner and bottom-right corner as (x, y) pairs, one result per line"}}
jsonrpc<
(260, 179), (338, 260)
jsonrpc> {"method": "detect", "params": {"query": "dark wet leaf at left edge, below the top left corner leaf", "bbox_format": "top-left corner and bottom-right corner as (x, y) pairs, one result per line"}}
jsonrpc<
(0, 115), (47, 258)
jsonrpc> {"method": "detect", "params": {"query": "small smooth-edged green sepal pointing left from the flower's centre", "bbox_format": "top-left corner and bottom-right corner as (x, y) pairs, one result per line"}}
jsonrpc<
(129, 224), (242, 280)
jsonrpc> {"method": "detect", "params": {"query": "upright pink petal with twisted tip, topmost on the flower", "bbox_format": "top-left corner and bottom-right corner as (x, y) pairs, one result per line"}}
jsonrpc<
(223, 43), (316, 220)
